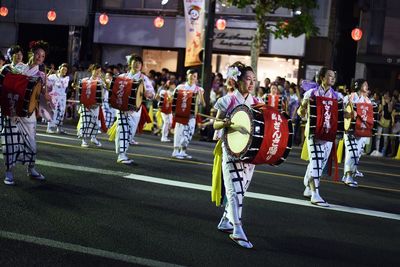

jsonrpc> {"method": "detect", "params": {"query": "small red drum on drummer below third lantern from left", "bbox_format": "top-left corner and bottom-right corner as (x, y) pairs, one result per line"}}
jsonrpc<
(79, 80), (103, 108)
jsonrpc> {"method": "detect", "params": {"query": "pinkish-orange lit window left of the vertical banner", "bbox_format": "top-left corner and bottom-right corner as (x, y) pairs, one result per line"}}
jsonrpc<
(143, 49), (178, 72)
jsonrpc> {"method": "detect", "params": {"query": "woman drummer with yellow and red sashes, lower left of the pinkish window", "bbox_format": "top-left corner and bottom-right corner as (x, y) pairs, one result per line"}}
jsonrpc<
(115, 54), (154, 165)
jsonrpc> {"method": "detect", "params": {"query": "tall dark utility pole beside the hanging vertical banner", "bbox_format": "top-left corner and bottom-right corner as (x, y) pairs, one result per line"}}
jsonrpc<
(201, 0), (216, 112)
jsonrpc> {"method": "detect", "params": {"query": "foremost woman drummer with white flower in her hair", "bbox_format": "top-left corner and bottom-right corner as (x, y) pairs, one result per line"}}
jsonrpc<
(214, 62), (257, 248)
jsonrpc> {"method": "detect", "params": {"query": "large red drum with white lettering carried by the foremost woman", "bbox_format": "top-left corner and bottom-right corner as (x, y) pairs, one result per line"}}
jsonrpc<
(223, 105), (293, 165)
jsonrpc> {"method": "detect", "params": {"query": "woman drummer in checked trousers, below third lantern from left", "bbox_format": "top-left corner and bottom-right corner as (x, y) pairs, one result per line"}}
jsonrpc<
(78, 64), (107, 148)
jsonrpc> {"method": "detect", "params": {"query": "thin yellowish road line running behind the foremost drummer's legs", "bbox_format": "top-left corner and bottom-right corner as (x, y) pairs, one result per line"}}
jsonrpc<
(33, 141), (400, 192)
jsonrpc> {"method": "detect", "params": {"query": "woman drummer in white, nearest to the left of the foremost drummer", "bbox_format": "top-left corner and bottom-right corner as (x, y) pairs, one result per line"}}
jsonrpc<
(172, 69), (205, 159)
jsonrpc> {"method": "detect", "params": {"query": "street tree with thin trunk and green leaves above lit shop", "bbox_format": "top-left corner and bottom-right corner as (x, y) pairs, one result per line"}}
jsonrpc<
(221, 0), (318, 73)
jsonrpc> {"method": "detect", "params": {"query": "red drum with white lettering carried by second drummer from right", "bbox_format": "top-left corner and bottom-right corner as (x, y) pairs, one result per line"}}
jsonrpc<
(309, 96), (344, 142)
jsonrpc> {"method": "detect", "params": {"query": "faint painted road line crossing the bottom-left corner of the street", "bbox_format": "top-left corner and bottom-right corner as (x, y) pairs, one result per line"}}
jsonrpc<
(0, 230), (179, 267)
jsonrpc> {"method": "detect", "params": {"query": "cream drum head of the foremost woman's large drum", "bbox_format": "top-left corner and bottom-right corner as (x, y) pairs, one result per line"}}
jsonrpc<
(226, 106), (252, 157)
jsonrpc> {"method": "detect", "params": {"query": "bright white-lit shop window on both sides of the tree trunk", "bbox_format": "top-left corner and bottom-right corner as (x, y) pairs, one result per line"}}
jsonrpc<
(212, 54), (299, 83)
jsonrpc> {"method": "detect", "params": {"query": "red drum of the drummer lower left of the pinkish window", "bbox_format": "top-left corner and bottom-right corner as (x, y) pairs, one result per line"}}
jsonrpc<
(109, 77), (145, 111)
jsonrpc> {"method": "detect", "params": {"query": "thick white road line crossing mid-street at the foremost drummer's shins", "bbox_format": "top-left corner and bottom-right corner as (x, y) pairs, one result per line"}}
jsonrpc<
(32, 160), (400, 220)
